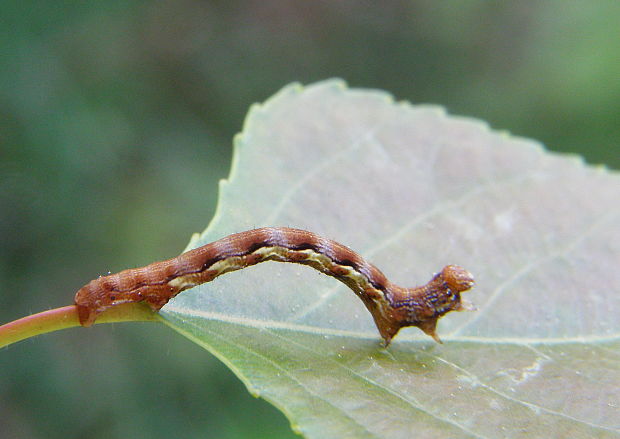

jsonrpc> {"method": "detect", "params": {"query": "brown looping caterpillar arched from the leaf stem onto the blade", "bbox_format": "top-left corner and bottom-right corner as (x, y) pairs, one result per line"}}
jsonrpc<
(75, 227), (475, 346)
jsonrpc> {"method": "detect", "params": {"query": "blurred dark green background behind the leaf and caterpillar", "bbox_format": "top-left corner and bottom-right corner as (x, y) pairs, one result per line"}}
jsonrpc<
(0, 0), (620, 438)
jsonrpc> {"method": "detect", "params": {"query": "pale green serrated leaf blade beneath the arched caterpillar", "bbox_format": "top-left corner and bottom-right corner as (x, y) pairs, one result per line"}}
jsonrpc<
(162, 81), (620, 438)
